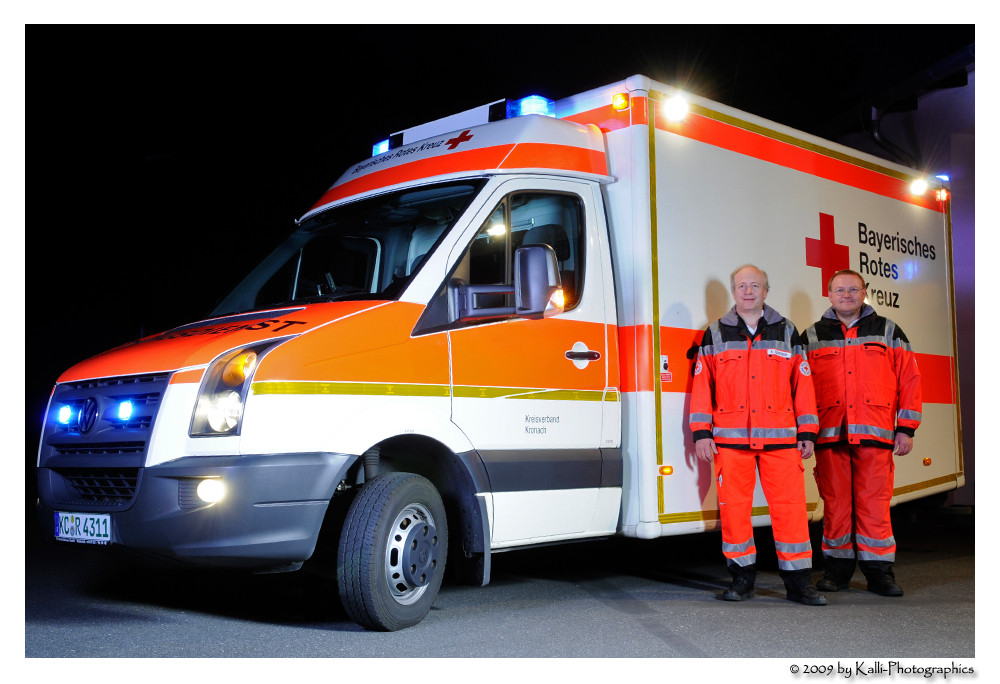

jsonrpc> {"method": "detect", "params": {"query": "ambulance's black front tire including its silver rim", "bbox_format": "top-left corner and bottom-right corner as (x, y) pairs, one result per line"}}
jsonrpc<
(337, 473), (448, 631)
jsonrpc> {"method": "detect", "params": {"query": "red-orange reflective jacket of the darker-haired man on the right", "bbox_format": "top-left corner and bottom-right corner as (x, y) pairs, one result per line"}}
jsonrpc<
(805, 304), (923, 448)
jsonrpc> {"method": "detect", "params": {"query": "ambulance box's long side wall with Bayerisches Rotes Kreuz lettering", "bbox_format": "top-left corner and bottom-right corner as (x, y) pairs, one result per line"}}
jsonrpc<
(653, 95), (962, 534)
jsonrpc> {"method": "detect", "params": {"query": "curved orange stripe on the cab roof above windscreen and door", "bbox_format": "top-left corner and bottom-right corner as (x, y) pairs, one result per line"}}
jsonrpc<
(312, 143), (608, 209)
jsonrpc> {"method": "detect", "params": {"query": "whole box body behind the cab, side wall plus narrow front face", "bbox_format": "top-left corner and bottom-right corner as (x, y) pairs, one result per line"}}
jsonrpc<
(573, 84), (964, 537)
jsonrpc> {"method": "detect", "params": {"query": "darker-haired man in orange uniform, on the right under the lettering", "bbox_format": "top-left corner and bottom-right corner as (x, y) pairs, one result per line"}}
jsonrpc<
(805, 270), (922, 596)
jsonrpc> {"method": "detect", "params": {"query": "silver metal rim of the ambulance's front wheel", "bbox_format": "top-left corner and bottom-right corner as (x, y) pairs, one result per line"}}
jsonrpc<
(385, 503), (441, 605)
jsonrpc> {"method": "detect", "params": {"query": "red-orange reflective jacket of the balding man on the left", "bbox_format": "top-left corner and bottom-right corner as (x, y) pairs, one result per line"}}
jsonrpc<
(689, 305), (818, 449)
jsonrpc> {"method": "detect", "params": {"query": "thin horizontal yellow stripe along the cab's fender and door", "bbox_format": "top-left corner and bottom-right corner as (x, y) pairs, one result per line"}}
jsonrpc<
(252, 381), (618, 402)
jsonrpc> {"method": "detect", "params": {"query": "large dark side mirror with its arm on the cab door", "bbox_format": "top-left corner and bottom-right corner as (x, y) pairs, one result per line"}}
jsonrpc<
(448, 245), (564, 321)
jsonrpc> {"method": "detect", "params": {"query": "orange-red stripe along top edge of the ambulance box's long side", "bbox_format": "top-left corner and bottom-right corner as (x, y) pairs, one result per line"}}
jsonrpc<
(656, 112), (943, 211)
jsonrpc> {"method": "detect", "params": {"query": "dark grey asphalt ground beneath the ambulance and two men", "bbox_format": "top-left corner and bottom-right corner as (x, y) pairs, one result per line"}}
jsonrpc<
(24, 502), (987, 681)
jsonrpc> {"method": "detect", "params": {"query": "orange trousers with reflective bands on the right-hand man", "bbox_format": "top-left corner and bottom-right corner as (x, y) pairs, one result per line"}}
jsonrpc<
(816, 446), (896, 563)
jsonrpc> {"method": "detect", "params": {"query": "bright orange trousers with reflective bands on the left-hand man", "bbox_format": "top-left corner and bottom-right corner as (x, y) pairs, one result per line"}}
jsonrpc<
(715, 447), (812, 571)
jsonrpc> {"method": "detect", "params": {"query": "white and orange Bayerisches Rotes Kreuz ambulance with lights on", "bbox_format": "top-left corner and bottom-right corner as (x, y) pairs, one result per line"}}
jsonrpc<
(37, 76), (965, 630)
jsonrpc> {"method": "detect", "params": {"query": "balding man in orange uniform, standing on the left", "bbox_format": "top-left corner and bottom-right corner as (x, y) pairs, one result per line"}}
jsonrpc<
(690, 264), (826, 606)
